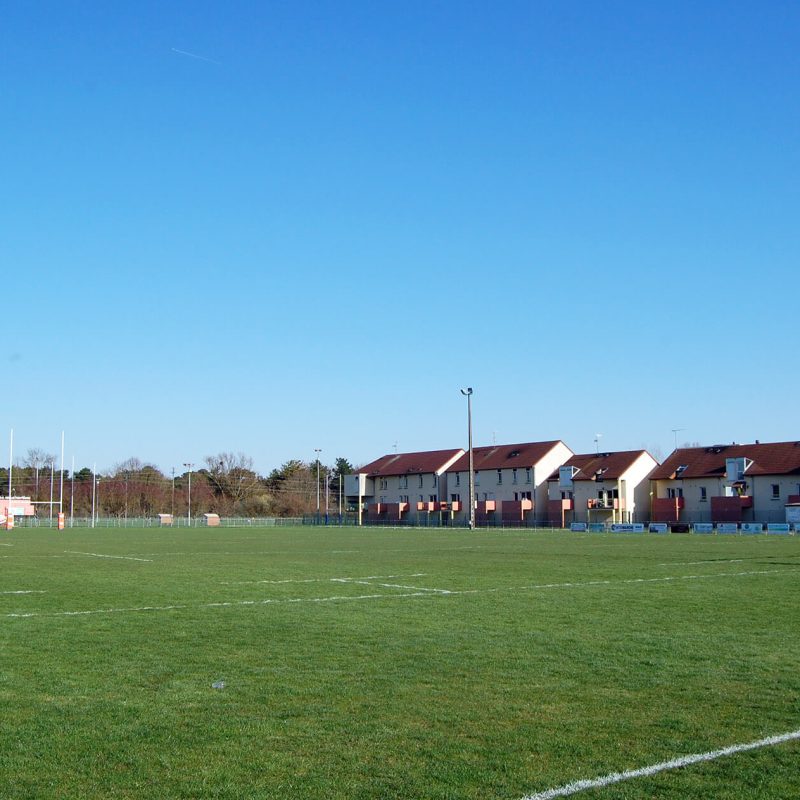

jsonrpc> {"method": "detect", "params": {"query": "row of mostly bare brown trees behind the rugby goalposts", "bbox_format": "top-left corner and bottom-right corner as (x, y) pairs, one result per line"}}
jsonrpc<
(0, 449), (353, 518)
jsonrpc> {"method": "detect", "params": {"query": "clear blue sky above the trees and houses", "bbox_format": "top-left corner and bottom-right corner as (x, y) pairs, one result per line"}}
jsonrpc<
(6, 0), (800, 472)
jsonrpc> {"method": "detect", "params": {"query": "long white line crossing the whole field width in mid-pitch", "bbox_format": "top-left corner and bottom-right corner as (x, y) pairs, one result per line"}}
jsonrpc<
(0, 569), (800, 619)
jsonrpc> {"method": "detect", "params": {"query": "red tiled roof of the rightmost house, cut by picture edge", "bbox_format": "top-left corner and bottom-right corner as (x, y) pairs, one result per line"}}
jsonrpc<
(650, 442), (800, 480)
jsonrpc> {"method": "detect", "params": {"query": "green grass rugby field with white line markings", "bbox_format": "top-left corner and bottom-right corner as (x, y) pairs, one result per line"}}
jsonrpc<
(0, 528), (800, 800)
